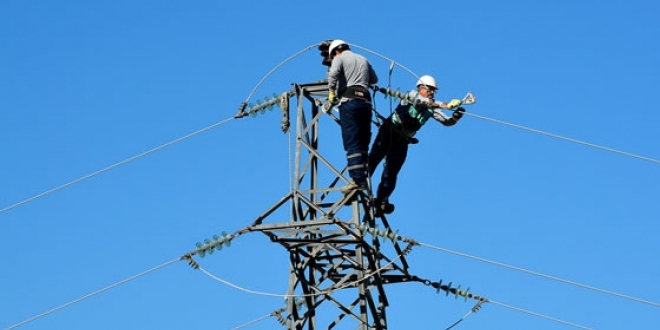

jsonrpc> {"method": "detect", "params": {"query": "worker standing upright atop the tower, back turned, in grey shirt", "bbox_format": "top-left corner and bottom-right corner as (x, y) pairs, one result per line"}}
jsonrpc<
(328, 40), (378, 193)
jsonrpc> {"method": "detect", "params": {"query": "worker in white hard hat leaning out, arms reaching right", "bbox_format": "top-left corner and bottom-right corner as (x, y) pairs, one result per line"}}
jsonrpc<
(369, 75), (465, 216)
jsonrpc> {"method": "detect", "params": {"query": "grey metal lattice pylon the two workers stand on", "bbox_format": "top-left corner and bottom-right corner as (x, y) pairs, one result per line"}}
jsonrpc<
(250, 82), (412, 330)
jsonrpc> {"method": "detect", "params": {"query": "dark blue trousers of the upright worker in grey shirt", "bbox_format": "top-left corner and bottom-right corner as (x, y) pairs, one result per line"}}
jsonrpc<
(339, 99), (372, 187)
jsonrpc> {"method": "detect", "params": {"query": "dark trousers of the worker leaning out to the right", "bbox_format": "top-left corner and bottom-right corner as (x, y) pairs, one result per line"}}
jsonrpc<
(369, 122), (408, 202)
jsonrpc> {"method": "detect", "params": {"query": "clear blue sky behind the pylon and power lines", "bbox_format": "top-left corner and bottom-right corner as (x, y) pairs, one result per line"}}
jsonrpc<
(0, 0), (660, 330)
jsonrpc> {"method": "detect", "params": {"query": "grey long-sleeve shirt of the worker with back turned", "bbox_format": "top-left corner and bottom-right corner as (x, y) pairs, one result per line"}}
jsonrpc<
(328, 50), (378, 95)
